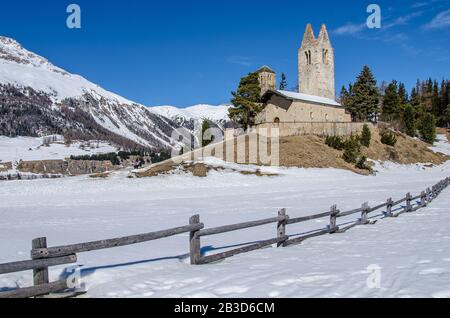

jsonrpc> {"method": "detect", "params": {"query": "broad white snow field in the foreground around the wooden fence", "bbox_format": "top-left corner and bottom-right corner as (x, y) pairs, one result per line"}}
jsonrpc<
(0, 137), (450, 298)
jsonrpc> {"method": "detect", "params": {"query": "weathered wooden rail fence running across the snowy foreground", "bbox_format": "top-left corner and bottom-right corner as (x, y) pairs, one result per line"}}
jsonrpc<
(0, 178), (450, 298)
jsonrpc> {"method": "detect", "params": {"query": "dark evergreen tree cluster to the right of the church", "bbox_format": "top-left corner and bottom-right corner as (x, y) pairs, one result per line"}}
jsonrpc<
(340, 66), (450, 144)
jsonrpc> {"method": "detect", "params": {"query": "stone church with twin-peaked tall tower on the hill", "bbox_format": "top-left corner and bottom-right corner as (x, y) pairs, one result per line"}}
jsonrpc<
(255, 24), (361, 136)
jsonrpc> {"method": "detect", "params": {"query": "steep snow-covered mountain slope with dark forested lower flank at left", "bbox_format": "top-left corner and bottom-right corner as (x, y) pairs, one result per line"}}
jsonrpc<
(0, 37), (186, 148)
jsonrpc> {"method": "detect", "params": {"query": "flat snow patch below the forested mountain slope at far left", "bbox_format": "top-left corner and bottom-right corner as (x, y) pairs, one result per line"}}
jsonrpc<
(0, 136), (117, 162)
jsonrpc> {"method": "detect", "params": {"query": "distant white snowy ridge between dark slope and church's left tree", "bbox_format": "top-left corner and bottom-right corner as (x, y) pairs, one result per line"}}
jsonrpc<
(149, 105), (231, 122)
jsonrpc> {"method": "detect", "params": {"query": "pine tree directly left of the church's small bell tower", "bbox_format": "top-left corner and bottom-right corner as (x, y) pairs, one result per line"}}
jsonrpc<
(229, 73), (262, 129)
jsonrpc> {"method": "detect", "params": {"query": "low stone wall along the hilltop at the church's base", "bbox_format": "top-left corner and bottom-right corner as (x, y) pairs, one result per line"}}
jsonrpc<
(257, 122), (374, 137)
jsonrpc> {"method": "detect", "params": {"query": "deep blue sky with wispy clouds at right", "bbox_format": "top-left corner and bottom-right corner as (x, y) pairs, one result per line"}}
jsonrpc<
(0, 0), (450, 107)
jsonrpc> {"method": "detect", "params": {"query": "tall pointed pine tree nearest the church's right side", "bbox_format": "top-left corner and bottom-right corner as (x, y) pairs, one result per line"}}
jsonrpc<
(345, 65), (380, 121)
